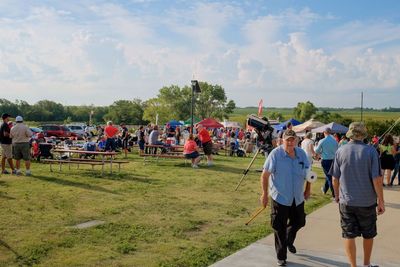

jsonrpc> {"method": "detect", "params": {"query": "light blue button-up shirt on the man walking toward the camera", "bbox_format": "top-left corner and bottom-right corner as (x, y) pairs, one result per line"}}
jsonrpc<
(264, 145), (310, 206)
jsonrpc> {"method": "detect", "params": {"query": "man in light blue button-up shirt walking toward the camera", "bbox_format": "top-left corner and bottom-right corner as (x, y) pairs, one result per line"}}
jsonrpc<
(260, 129), (311, 266)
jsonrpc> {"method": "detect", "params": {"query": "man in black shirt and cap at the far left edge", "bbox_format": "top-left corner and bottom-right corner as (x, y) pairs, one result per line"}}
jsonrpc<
(0, 113), (15, 174)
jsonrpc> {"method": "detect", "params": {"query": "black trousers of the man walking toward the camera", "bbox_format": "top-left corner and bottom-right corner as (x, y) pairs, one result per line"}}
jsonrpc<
(271, 200), (306, 260)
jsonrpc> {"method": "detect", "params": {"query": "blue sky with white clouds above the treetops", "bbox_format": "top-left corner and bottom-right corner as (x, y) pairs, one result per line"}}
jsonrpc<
(0, 0), (400, 108)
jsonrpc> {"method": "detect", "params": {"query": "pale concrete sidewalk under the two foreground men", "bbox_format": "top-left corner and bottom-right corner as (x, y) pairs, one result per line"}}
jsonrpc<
(211, 186), (400, 267)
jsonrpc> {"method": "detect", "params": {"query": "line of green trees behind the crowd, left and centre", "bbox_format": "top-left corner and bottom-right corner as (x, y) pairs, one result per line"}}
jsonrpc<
(0, 82), (236, 125)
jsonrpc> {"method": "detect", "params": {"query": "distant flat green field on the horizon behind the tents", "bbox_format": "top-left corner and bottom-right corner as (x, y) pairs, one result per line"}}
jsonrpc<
(229, 107), (400, 123)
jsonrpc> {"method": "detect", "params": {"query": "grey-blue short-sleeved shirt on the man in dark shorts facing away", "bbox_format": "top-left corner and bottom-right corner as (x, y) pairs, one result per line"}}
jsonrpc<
(330, 141), (381, 207)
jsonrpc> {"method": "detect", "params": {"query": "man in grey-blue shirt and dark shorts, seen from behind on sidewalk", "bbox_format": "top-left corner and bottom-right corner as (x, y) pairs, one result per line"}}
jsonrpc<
(330, 122), (385, 267)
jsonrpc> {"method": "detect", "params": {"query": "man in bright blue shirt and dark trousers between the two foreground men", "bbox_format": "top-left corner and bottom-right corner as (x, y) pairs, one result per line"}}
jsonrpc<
(315, 127), (338, 198)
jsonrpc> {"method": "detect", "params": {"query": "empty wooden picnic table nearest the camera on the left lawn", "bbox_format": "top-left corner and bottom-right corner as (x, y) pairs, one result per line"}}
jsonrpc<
(45, 148), (122, 175)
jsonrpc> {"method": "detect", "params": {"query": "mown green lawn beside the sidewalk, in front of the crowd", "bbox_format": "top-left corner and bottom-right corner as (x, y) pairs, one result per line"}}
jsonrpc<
(0, 154), (330, 267)
